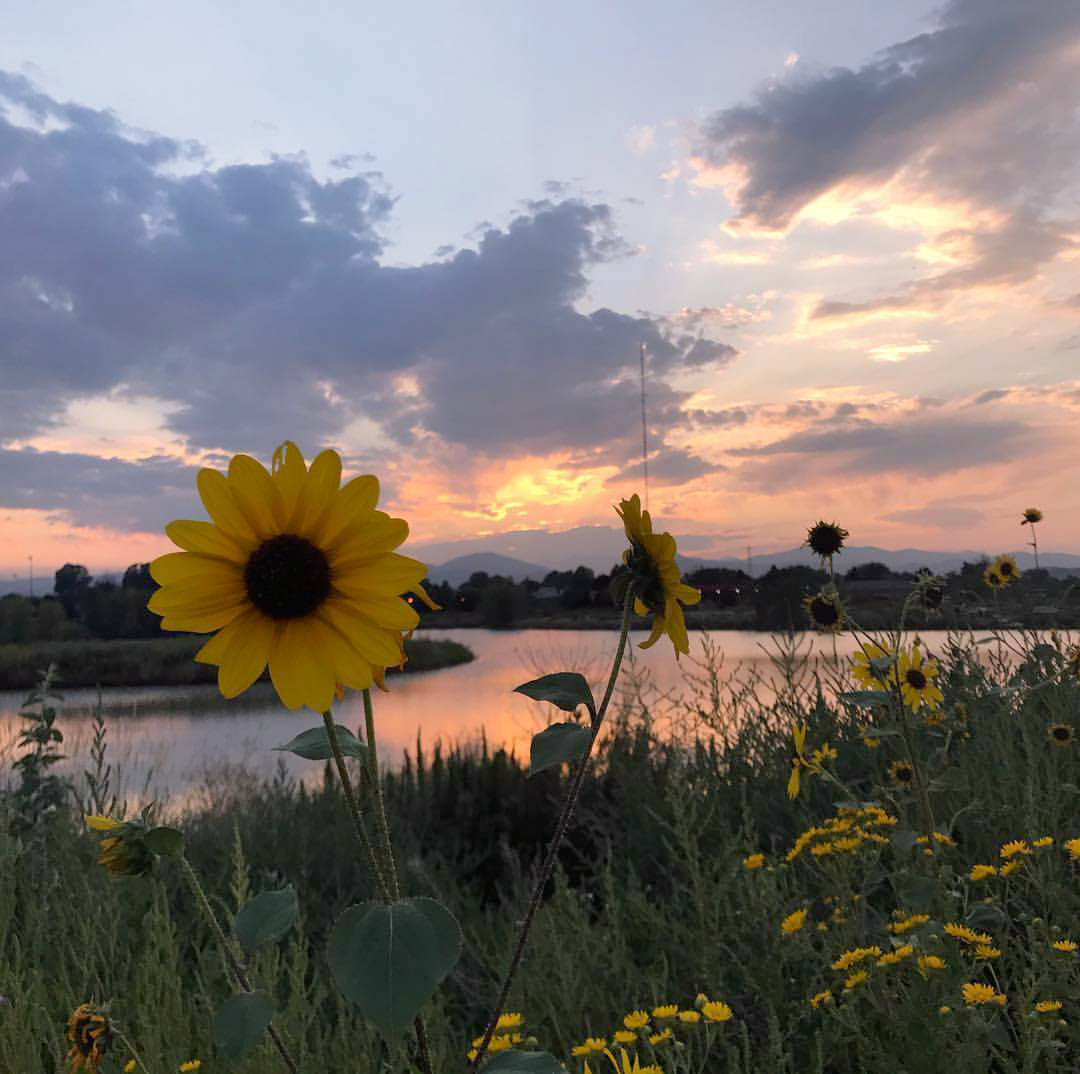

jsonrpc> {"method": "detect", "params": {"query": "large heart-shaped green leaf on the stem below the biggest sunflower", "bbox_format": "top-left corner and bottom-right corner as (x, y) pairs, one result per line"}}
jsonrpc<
(327, 897), (461, 1045)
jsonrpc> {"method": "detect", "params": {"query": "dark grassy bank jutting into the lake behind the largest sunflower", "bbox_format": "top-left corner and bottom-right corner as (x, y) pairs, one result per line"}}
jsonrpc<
(0, 635), (473, 689)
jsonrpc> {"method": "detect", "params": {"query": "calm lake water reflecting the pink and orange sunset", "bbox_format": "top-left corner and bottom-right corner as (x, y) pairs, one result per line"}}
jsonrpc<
(0, 630), (1028, 802)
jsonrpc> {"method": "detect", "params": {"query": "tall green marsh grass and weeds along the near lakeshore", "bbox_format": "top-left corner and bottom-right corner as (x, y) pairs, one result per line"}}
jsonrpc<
(0, 634), (1080, 1074)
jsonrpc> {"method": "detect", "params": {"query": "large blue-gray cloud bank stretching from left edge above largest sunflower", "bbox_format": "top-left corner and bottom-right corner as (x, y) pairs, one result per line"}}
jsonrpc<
(0, 73), (737, 486)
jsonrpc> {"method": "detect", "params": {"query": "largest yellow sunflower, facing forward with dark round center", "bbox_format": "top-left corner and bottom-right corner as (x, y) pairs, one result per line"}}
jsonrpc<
(148, 441), (437, 712)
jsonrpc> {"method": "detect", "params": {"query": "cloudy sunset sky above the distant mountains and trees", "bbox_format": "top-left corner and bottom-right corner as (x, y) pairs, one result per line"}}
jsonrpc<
(0, 0), (1080, 576)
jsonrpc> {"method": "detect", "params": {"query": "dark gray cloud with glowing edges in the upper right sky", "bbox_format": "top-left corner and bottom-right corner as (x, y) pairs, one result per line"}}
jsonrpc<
(699, 0), (1080, 318)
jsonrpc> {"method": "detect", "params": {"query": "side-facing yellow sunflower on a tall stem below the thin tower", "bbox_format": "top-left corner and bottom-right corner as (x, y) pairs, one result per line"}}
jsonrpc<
(616, 493), (701, 658)
